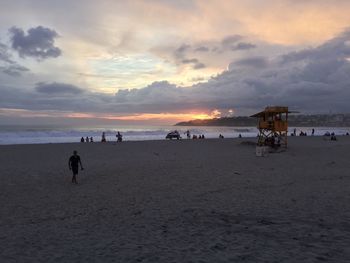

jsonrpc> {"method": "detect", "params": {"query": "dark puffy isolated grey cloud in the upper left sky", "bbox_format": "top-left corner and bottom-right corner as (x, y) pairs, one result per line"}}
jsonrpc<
(9, 26), (62, 60)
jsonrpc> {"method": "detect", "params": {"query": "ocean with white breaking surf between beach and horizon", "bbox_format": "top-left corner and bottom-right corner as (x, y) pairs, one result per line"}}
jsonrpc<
(0, 125), (350, 145)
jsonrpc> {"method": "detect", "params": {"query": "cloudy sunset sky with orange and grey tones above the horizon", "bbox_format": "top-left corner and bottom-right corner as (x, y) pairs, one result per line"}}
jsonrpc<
(0, 0), (350, 125)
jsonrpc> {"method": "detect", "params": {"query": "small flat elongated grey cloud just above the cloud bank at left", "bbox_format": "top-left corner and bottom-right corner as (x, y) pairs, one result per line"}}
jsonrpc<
(35, 82), (84, 95)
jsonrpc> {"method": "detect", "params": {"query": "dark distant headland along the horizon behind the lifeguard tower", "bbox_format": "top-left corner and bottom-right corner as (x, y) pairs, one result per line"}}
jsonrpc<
(175, 114), (350, 127)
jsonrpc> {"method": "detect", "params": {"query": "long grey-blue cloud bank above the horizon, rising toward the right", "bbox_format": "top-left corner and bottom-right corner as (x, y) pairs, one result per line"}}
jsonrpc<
(0, 30), (350, 114)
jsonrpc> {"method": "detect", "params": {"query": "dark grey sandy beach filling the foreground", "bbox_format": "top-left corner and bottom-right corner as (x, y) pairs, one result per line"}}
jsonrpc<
(0, 136), (350, 262)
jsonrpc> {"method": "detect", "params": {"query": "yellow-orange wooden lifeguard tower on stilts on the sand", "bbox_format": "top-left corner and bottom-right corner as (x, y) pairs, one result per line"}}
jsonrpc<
(250, 106), (291, 147)
